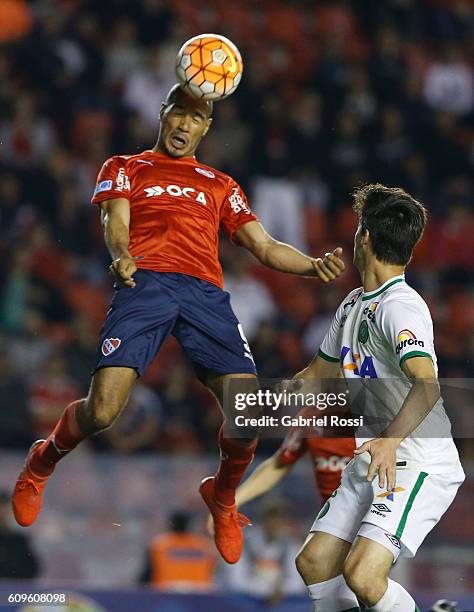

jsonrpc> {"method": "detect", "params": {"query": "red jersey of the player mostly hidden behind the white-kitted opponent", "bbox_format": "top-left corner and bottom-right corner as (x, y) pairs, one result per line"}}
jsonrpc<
(279, 427), (355, 501)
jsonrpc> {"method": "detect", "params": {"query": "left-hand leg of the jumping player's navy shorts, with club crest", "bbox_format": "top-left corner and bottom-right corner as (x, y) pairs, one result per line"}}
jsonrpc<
(94, 270), (178, 375)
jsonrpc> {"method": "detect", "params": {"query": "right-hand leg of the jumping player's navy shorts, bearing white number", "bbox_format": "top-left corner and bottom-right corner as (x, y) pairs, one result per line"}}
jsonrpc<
(173, 276), (256, 380)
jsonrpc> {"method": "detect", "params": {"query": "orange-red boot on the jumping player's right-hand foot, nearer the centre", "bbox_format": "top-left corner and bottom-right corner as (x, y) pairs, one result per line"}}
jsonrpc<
(199, 476), (252, 563)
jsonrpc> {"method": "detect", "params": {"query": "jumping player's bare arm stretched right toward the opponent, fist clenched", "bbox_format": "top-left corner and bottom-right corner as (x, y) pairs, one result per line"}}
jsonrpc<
(234, 221), (345, 283)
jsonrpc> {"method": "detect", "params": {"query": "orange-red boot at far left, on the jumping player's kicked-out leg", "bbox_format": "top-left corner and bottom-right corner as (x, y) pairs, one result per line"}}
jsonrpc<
(12, 440), (48, 527)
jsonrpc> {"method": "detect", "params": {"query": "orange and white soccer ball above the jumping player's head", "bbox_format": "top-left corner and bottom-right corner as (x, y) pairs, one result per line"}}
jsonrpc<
(176, 34), (244, 100)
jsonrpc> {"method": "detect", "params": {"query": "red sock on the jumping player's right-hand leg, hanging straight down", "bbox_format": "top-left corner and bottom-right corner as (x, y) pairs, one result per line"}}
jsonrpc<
(214, 425), (258, 506)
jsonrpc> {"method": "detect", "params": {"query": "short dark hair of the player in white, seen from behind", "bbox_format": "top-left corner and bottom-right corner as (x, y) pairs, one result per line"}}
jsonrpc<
(353, 183), (428, 266)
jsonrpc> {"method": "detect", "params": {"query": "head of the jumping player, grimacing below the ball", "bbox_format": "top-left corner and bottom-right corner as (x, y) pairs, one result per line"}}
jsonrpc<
(158, 85), (212, 157)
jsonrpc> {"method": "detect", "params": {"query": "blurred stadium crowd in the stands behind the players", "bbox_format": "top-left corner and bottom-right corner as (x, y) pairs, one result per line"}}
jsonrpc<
(0, 0), (474, 453)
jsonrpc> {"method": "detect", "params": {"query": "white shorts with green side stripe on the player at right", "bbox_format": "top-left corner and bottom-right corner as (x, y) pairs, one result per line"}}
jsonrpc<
(311, 456), (464, 560)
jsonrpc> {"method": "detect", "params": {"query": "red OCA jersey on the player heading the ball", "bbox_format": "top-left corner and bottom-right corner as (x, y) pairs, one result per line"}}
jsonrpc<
(92, 151), (257, 288)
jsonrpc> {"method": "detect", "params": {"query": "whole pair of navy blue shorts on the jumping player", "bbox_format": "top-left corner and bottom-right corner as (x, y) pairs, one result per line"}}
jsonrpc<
(94, 270), (256, 379)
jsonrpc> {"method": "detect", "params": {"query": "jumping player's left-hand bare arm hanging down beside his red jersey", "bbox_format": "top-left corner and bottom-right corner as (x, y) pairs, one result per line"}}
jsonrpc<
(100, 198), (137, 287)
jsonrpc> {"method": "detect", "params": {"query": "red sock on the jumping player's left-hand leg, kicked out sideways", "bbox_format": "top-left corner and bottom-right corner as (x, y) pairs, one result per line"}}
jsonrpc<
(29, 400), (86, 477)
